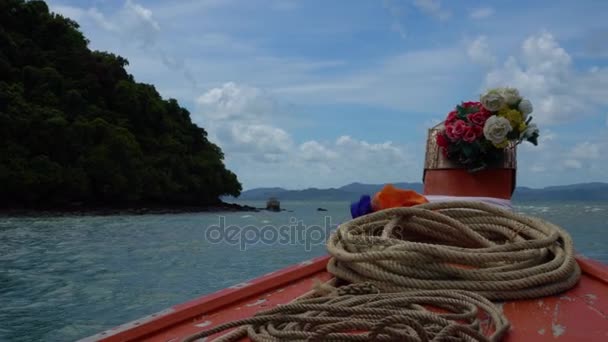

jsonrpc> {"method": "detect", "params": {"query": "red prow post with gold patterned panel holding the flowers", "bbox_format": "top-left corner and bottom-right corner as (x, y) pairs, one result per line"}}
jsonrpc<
(423, 125), (517, 199)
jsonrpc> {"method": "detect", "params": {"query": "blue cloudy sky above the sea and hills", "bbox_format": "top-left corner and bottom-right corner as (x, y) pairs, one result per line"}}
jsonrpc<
(48, 0), (608, 189)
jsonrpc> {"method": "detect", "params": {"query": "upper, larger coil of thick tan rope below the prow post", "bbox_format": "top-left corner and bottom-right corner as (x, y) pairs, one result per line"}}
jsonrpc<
(327, 202), (581, 300)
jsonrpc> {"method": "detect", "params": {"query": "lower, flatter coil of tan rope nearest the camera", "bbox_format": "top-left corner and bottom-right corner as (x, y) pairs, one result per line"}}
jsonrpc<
(183, 285), (509, 342)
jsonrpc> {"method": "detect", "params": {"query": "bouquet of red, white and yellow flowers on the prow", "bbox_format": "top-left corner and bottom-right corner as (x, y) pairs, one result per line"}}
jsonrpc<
(436, 88), (539, 171)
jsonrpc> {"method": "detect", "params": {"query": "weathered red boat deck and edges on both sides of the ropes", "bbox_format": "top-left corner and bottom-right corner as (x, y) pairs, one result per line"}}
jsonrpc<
(81, 256), (608, 342)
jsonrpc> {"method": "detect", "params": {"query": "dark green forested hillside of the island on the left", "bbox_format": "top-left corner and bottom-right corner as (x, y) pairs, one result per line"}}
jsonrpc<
(0, 0), (241, 208)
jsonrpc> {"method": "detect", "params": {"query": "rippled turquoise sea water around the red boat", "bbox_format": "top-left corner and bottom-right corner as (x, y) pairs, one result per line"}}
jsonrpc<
(0, 202), (608, 341)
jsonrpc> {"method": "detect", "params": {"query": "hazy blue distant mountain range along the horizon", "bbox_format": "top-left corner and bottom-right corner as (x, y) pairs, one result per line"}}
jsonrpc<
(232, 183), (608, 201)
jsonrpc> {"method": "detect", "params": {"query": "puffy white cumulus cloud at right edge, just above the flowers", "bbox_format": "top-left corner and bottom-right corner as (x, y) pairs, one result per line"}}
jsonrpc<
(485, 32), (608, 124)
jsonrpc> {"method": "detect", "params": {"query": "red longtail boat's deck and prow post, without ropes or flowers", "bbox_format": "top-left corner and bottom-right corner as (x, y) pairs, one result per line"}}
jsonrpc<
(81, 126), (608, 342)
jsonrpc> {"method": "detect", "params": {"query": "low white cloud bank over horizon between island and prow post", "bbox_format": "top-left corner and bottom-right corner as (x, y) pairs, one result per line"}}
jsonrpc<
(238, 136), (421, 188)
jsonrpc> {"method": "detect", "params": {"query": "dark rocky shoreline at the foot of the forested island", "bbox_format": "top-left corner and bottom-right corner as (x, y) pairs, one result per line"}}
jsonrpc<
(0, 202), (260, 216)
